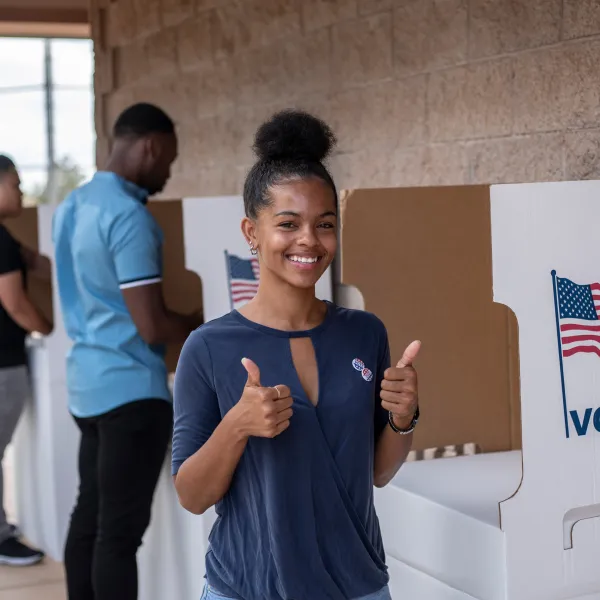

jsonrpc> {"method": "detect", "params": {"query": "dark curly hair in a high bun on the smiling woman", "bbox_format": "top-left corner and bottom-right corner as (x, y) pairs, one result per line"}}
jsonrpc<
(244, 110), (337, 219)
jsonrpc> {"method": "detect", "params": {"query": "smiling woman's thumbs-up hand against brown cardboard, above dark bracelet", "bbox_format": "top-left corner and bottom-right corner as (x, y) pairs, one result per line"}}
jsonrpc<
(380, 341), (421, 429)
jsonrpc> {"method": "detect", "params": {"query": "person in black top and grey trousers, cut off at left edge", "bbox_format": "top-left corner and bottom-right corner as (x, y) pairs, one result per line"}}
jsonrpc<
(0, 155), (52, 566)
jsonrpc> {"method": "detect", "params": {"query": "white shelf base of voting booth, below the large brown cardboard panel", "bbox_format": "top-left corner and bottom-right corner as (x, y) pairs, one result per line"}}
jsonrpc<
(375, 451), (521, 600)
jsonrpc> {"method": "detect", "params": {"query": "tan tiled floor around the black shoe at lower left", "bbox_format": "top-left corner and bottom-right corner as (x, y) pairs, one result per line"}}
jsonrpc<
(0, 448), (67, 600)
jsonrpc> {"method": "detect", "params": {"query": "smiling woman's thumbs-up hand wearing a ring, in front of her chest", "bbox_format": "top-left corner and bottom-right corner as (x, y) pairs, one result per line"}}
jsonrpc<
(235, 358), (293, 438)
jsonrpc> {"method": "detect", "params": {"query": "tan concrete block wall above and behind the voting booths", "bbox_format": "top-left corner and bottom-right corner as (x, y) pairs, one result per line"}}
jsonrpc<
(92, 0), (600, 197)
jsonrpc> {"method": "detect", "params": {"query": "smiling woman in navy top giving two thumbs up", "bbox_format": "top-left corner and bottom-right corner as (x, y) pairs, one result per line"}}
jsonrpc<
(172, 111), (418, 600)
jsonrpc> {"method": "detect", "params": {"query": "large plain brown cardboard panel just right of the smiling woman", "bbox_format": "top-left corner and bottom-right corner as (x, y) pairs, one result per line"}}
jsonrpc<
(341, 186), (521, 452)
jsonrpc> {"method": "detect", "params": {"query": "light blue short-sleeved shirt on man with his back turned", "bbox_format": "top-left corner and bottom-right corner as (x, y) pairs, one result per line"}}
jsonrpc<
(52, 171), (170, 417)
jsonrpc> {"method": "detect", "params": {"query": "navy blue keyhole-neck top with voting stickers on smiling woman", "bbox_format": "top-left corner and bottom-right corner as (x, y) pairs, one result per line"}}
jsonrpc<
(172, 303), (390, 600)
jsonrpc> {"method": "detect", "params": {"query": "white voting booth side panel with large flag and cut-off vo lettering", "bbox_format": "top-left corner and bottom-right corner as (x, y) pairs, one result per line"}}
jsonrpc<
(491, 181), (600, 600)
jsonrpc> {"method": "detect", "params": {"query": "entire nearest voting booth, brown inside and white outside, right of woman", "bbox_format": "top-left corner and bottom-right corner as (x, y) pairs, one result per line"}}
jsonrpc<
(341, 182), (600, 600)
